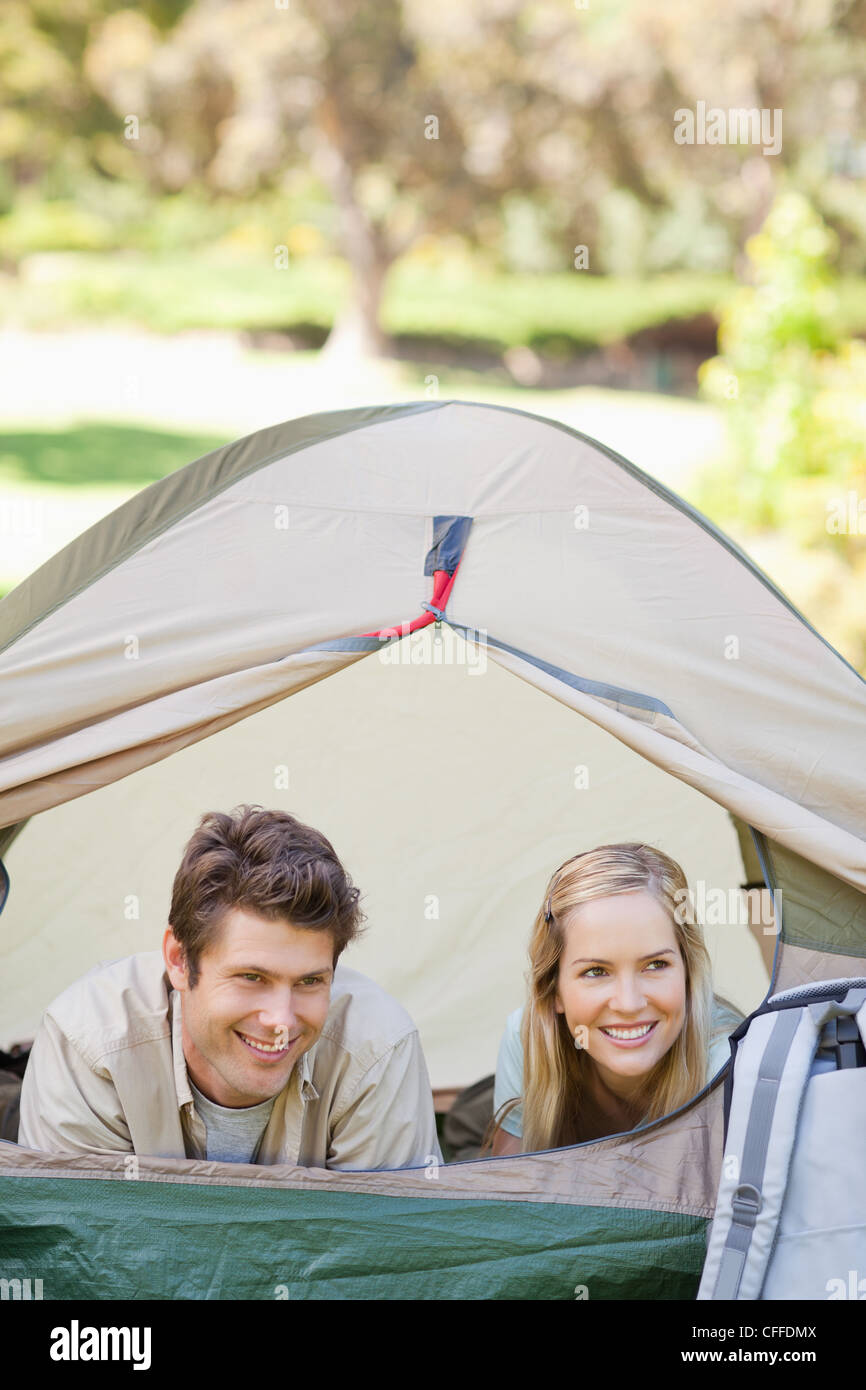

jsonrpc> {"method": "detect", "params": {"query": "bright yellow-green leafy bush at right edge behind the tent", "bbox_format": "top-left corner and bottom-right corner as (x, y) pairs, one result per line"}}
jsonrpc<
(699, 192), (866, 549)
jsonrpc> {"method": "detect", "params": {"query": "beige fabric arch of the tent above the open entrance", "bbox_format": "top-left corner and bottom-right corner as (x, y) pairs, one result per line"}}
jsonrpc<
(0, 402), (866, 885)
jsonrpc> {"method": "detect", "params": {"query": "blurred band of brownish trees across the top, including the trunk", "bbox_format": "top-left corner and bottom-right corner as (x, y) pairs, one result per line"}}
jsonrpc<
(0, 0), (866, 350)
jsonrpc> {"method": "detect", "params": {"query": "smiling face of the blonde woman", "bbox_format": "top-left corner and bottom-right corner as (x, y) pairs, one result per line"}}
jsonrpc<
(556, 890), (685, 1099)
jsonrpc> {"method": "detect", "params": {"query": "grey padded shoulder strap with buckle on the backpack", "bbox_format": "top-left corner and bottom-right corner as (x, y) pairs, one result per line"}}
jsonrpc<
(698, 988), (865, 1300)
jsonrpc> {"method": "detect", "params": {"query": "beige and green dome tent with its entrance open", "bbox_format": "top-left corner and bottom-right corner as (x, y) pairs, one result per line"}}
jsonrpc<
(0, 400), (866, 1298)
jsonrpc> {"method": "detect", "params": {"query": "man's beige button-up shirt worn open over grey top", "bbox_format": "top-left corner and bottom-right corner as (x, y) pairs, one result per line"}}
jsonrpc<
(18, 951), (442, 1170)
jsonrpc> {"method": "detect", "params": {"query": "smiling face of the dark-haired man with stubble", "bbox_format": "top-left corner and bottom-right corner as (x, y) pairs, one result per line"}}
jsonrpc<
(163, 908), (334, 1108)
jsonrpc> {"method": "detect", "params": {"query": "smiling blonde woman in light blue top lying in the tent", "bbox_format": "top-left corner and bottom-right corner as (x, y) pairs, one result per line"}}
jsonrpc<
(492, 844), (741, 1154)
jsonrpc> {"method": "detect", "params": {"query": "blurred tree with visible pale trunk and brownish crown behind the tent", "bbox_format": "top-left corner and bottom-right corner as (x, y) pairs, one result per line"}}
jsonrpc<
(79, 0), (480, 353)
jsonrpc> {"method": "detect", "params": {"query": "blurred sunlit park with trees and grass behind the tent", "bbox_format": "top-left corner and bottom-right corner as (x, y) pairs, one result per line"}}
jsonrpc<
(0, 0), (866, 670)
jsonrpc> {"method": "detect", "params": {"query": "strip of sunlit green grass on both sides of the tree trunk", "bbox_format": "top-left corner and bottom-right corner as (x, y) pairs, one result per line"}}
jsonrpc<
(3, 252), (733, 344)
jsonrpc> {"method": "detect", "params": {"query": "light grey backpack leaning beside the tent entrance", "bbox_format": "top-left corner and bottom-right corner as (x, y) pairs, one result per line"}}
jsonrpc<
(698, 979), (866, 1300)
